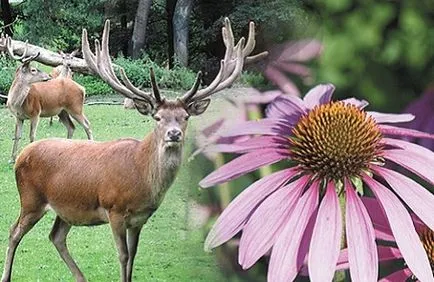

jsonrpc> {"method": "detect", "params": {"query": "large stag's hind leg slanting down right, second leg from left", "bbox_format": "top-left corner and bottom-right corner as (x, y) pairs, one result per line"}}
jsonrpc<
(49, 216), (86, 282)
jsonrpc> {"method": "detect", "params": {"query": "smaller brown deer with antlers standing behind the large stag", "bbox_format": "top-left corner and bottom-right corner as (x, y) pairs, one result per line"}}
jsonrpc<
(0, 37), (92, 162)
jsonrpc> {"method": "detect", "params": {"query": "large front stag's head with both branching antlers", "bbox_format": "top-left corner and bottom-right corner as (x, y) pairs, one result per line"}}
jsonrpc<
(82, 18), (267, 146)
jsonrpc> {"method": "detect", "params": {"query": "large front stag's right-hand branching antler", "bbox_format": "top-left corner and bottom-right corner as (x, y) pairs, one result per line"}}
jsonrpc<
(180, 18), (268, 104)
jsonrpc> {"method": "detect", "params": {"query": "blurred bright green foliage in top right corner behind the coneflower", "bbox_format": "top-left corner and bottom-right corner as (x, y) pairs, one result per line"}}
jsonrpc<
(311, 0), (434, 112)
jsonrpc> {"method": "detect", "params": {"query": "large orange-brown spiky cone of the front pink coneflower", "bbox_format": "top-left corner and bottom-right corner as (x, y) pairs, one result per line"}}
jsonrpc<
(290, 102), (382, 180)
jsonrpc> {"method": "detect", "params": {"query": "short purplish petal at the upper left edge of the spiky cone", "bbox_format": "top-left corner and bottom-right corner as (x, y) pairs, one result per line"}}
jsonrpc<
(265, 95), (307, 119)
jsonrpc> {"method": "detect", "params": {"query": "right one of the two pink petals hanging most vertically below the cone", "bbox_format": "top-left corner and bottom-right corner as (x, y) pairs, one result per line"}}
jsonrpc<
(345, 180), (378, 282)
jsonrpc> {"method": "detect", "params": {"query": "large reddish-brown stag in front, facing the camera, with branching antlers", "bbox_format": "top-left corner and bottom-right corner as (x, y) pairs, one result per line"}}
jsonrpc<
(2, 19), (262, 282)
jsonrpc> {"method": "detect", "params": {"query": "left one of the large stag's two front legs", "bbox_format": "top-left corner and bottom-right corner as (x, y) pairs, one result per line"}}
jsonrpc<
(109, 213), (128, 282)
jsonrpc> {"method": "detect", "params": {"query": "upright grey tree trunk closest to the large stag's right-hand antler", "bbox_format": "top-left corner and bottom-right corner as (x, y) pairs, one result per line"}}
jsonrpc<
(173, 0), (193, 66)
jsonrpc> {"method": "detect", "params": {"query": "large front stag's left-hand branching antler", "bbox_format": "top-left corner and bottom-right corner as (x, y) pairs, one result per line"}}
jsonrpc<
(82, 20), (161, 108)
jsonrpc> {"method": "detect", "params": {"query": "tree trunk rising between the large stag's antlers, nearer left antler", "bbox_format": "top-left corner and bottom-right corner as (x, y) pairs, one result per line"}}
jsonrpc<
(131, 0), (152, 59)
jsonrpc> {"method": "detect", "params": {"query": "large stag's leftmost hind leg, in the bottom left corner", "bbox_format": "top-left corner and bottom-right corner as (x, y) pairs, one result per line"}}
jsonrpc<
(2, 209), (45, 282)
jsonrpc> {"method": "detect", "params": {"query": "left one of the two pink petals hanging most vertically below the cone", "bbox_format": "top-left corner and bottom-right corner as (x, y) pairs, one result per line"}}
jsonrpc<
(309, 181), (342, 281)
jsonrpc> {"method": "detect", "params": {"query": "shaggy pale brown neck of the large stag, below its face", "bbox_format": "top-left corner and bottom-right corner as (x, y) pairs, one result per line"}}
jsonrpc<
(142, 131), (183, 205)
